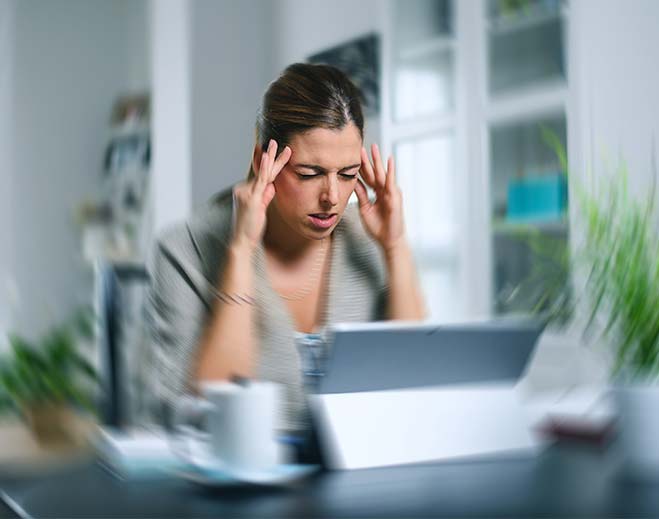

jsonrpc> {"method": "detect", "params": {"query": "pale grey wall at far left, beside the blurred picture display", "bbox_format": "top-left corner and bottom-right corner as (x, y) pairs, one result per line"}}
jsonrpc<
(9, 0), (148, 336)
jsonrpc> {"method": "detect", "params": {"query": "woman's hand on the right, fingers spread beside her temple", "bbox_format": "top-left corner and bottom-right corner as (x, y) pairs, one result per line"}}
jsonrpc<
(355, 144), (405, 253)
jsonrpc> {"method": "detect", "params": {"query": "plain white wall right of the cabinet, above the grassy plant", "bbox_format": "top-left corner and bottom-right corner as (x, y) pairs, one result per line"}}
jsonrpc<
(569, 0), (659, 198)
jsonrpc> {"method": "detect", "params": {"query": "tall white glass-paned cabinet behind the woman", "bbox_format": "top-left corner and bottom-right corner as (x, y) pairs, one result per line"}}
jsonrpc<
(382, 0), (569, 320)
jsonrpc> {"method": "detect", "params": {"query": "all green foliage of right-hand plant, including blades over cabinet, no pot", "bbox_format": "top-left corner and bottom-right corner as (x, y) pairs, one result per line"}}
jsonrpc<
(518, 128), (659, 380)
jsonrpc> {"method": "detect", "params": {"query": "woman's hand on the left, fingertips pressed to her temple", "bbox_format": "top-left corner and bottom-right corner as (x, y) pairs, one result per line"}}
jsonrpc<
(233, 139), (292, 251)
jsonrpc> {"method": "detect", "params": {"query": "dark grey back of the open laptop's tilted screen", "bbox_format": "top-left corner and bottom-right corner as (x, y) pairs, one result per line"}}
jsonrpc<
(317, 319), (544, 394)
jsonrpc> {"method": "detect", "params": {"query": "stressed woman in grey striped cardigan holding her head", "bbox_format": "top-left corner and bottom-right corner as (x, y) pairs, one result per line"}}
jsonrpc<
(150, 63), (424, 438)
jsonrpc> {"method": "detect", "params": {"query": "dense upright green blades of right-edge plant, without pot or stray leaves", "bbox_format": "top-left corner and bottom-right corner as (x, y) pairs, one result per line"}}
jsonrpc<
(580, 165), (659, 379)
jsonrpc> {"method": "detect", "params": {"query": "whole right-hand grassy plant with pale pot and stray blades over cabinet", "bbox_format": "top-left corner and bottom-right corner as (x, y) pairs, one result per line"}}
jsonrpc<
(520, 131), (659, 474)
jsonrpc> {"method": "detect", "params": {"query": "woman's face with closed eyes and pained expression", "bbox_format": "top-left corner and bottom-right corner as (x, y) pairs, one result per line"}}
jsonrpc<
(272, 123), (362, 239)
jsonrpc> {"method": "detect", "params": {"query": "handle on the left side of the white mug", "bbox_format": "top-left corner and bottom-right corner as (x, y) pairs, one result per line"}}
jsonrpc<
(172, 396), (217, 470)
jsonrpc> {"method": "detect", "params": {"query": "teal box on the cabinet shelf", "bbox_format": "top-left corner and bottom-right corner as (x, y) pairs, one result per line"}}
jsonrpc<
(506, 172), (567, 222)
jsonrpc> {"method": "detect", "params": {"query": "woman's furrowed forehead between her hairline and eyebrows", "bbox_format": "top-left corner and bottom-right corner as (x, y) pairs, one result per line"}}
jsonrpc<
(289, 124), (362, 167)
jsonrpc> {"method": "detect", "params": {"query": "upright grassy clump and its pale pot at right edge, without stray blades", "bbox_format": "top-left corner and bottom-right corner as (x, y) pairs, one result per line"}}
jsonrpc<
(582, 168), (659, 474)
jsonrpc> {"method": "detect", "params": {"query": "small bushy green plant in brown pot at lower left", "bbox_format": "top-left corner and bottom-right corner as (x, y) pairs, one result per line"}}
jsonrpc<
(0, 309), (97, 445)
